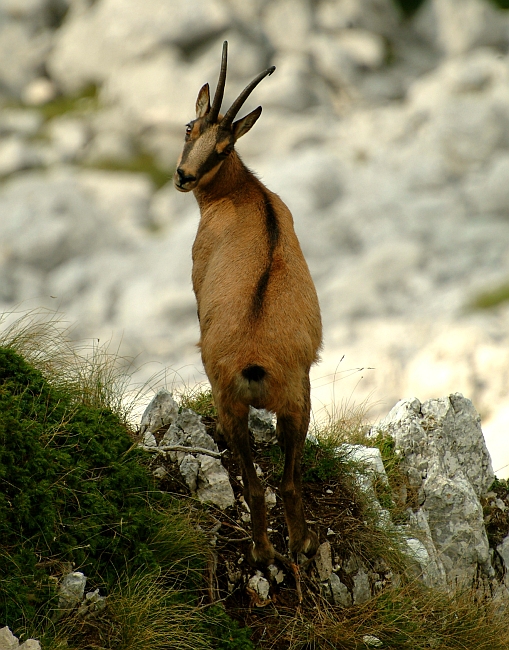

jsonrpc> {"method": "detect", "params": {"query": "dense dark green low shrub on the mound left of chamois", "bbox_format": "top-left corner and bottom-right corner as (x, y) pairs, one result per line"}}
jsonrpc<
(0, 348), (204, 630)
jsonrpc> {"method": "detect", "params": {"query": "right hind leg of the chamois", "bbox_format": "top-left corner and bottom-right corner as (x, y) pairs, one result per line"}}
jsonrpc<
(276, 377), (318, 555)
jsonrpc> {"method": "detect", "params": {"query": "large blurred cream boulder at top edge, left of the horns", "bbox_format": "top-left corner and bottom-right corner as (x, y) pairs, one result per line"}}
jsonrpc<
(48, 0), (229, 93)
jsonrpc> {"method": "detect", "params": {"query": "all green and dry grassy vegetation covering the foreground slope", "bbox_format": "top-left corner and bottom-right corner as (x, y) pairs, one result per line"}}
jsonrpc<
(0, 314), (509, 650)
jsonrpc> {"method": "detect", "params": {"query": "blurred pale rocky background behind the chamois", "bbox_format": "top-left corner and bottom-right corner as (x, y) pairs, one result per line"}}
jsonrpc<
(0, 0), (509, 477)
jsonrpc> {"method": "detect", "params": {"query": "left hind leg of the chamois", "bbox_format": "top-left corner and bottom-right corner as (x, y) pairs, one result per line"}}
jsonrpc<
(218, 407), (274, 565)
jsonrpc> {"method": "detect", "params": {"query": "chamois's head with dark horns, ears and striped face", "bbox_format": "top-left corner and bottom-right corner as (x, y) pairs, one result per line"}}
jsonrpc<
(173, 41), (275, 192)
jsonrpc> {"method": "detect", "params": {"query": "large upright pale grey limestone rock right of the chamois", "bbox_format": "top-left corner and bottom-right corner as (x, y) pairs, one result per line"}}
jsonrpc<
(374, 393), (494, 586)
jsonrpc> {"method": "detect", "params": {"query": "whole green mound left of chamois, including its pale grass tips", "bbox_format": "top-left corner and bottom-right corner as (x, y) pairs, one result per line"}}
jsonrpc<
(0, 314), (251, 650)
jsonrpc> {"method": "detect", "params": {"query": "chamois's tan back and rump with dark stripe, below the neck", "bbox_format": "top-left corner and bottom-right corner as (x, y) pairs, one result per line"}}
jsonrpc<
(193, 183), (322, 408)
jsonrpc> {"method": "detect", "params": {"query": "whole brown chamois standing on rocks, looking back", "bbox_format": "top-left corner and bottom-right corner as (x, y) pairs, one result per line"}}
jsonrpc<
(174, 41), (322, 564)
